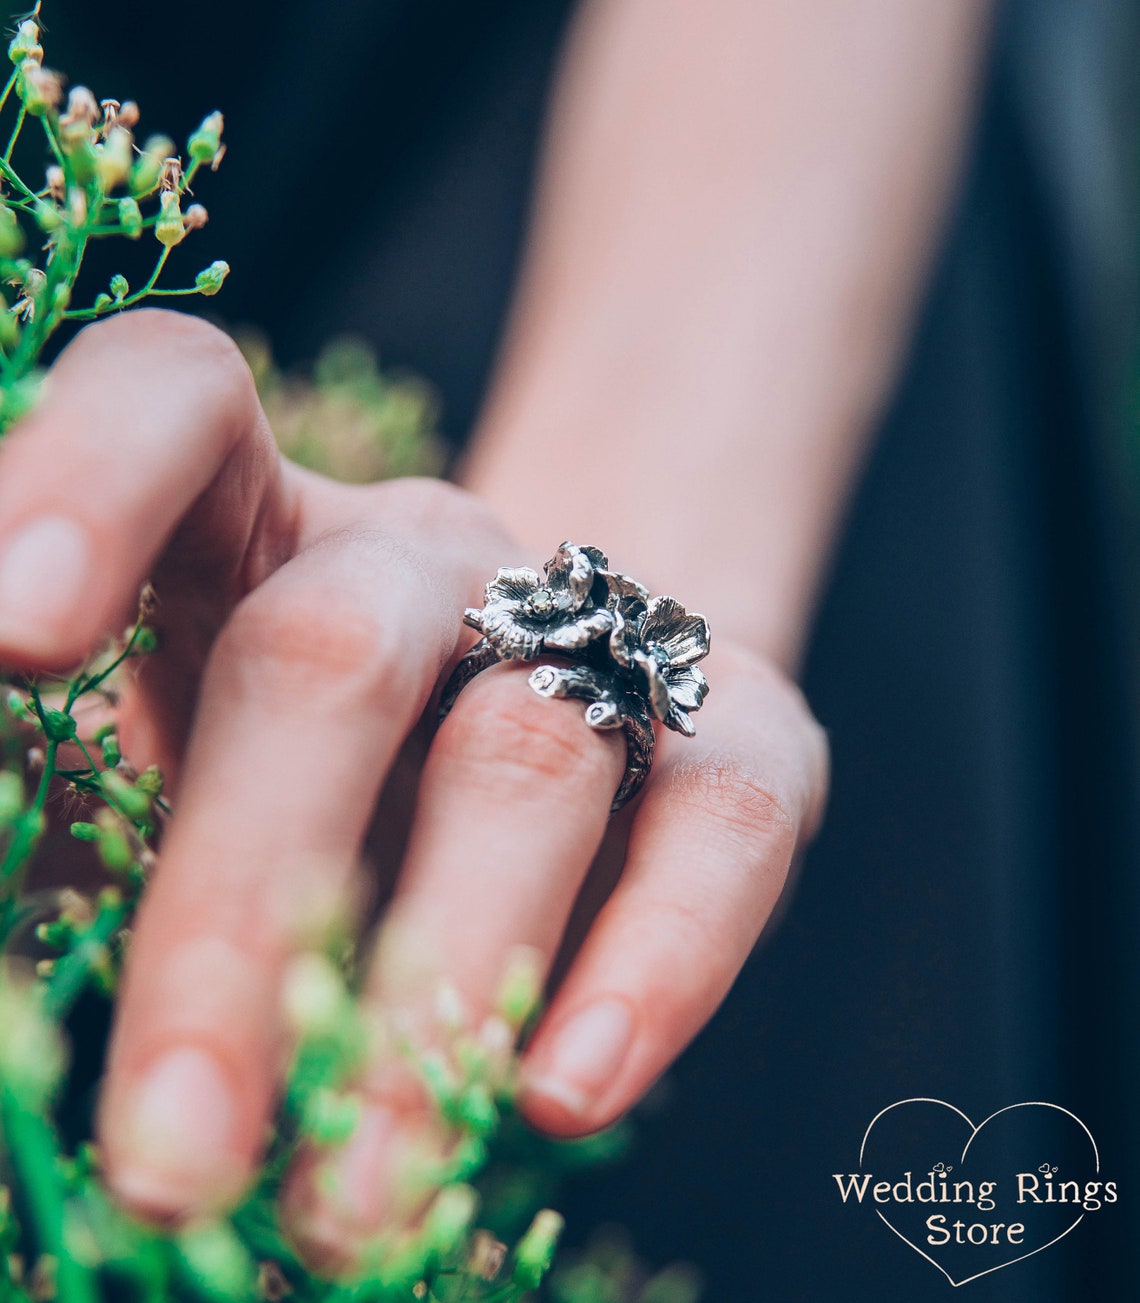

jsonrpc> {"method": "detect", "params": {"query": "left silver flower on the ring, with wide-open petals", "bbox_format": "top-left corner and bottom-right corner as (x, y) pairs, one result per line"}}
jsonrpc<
(464, 542), (615, 661)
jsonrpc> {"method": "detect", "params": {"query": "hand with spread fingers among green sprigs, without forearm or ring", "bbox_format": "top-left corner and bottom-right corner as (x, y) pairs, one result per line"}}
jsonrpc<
(0, 311), (827, 1255)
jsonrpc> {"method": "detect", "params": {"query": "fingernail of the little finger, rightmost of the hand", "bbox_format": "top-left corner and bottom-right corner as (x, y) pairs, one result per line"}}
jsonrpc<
(524, 995), (633, 1117)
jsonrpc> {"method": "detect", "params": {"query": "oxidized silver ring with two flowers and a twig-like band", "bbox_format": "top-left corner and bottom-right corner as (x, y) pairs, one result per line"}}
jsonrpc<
(439, 542), (709, 810)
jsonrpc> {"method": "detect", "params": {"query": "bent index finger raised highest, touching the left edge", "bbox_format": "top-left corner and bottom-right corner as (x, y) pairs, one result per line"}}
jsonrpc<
(0, 309), (287, 668)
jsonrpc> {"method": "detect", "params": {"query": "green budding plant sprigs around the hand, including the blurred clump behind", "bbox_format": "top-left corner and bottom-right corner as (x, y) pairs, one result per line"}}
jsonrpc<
(0, 7), (688, 1303)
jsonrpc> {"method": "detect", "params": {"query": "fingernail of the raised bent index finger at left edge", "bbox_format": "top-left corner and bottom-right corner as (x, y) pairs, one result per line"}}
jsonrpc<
(0, 516), (91, 652)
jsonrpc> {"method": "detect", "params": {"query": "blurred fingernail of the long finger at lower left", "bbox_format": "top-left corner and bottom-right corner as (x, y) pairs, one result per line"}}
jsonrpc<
(112, 1046), (240, 1216)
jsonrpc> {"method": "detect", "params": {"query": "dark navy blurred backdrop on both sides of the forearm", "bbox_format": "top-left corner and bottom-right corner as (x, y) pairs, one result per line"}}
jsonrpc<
(35, 0), (1140, 1303)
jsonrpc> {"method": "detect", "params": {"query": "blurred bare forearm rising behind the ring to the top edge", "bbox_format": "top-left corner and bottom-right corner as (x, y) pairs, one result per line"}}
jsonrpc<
(463, 0), (988, 665)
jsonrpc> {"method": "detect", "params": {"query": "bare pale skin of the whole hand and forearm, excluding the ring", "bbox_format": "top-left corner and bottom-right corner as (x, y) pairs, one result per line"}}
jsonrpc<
(0, 0), (985, 1264)
